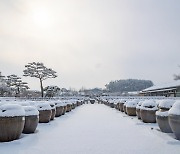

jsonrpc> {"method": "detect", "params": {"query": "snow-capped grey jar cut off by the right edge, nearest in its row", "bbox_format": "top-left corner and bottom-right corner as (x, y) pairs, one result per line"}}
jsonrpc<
(168, 100), (180, 140)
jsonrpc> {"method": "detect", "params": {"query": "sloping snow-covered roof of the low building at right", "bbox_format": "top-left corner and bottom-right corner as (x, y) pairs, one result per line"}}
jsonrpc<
(142, 81), (180, 92)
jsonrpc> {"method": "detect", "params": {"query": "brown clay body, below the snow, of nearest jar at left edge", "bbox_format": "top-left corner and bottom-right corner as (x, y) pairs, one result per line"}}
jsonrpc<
(0, 116), (25, 142)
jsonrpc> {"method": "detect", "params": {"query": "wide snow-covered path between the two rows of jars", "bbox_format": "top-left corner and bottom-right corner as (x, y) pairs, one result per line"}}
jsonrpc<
(0, 104), (180, 154)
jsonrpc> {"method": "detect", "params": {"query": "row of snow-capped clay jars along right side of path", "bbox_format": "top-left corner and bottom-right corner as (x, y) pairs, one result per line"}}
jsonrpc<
(101, 99), (180, 140)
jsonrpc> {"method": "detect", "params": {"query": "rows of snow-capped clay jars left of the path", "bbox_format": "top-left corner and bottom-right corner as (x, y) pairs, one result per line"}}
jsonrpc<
(0, 100), (83, 142)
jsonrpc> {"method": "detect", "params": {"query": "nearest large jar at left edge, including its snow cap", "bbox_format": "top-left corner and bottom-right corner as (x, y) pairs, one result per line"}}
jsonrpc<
(0, 104), (25, 142)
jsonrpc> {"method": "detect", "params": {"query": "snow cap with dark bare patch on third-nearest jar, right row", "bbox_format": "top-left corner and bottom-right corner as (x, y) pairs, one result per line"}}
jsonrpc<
(140, 100), (158, 111)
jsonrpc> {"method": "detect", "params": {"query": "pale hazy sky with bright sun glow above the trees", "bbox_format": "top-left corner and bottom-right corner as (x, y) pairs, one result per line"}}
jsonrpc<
(0, 0), (180, 89)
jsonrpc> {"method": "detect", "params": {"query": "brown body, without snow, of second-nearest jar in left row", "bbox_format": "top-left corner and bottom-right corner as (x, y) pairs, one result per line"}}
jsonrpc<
(23, 115), (39, 134)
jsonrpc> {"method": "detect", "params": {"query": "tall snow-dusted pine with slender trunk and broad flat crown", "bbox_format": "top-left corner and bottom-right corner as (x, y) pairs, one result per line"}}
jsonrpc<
(23, 62), (57, 97)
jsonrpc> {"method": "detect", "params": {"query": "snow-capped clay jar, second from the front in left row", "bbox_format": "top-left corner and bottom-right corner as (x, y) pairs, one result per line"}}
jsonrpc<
(23, 106), (39, 134)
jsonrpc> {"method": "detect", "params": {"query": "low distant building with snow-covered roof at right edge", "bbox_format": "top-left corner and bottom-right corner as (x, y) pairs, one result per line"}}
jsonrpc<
(140, 81), (180, 97)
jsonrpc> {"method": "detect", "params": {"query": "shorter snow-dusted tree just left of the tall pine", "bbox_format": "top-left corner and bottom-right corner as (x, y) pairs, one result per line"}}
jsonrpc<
(6, 74), (29, 96)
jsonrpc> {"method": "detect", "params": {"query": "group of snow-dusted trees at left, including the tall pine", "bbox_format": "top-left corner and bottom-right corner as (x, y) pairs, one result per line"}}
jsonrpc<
(0, 62), (57, 97)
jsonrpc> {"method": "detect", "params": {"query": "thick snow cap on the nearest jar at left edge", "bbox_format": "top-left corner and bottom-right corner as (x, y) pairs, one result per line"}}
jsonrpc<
(0, 104), (25, 117)
